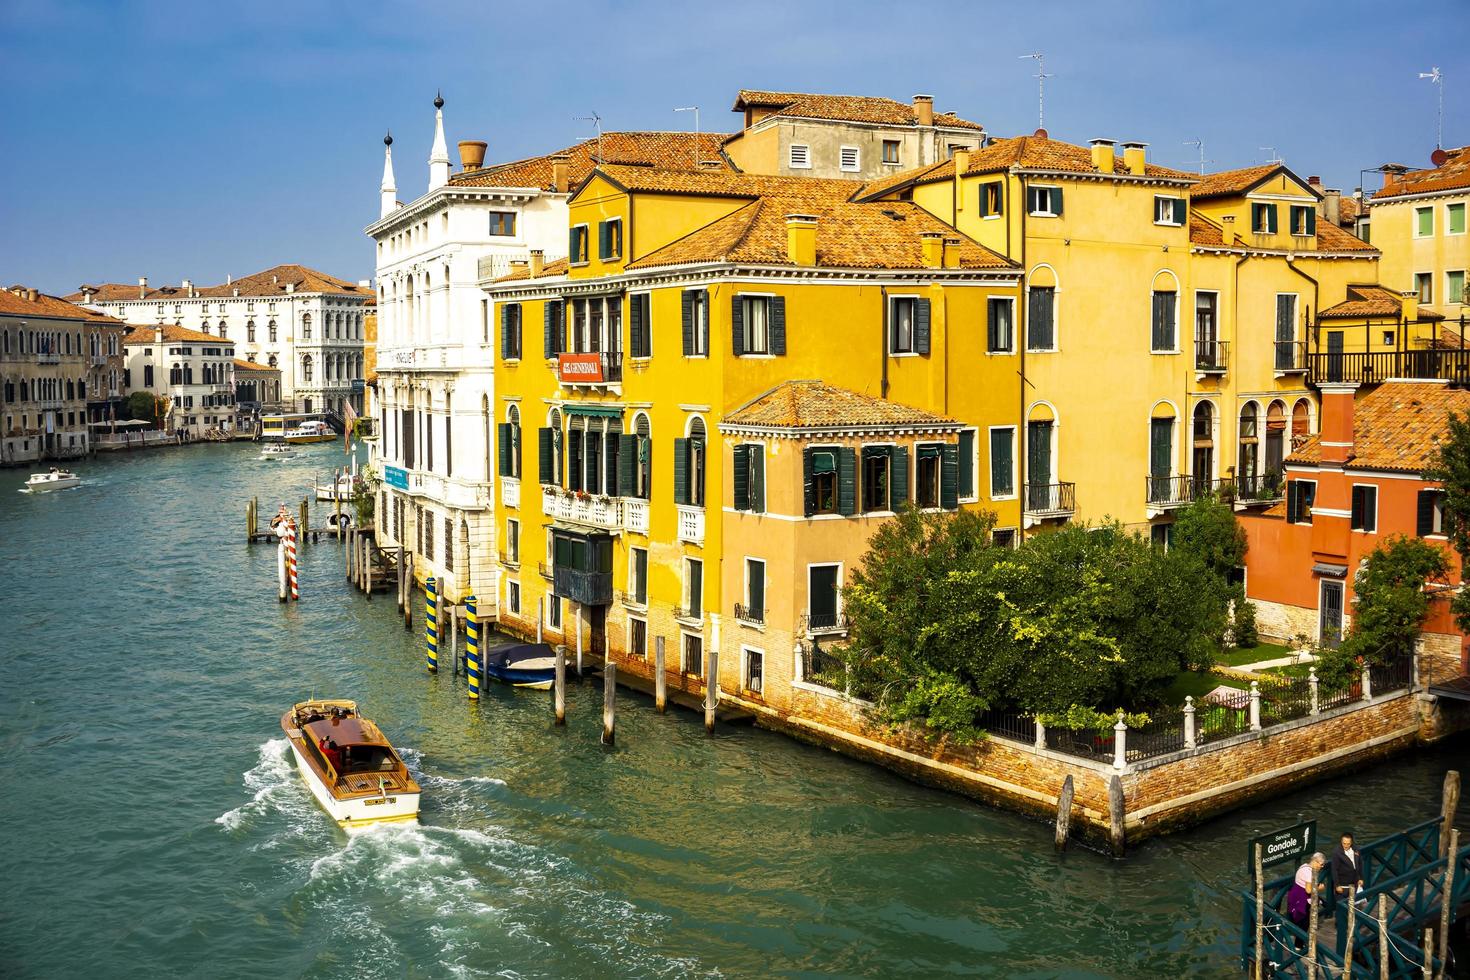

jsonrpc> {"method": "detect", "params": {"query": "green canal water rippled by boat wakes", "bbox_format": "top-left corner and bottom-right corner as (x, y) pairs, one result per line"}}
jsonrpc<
(0, 445), (1464, 979)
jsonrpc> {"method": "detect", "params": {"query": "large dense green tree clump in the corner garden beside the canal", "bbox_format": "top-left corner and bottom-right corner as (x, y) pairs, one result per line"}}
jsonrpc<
(841, 511), (1227, 738)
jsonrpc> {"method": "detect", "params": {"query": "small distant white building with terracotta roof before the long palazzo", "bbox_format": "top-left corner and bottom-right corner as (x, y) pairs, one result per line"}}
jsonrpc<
(122, 323), (235, 439)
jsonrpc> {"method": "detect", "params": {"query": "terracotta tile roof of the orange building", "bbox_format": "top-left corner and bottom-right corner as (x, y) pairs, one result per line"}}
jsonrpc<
(1286, 381), (1470, 473)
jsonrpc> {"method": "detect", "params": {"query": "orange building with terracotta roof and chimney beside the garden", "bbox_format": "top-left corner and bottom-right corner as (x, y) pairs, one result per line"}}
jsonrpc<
(1241, 381), (1470, 682)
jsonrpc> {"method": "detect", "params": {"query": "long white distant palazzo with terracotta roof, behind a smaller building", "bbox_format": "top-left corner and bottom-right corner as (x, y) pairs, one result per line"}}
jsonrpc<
(69, 264), (373, 414)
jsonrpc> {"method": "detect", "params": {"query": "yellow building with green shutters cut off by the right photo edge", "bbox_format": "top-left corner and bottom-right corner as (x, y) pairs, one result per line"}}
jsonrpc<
(1369, 147), (1470, 320)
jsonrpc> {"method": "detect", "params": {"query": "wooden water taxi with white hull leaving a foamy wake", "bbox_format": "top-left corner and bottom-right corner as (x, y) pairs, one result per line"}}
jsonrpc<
(281, 701), (420, 830)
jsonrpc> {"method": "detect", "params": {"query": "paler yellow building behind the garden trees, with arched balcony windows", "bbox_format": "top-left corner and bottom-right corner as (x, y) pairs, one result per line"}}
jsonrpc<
(864, 131), (1377, 539)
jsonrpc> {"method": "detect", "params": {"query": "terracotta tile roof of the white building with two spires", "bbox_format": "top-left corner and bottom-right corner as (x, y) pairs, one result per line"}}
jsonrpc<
(450, 132), (729, 191)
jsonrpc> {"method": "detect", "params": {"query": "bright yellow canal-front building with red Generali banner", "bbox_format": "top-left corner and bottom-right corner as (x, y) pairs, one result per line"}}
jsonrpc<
(485, 165), (1020, 710)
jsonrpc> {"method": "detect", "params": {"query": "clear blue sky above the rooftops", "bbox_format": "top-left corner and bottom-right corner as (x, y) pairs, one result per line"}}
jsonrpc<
(0, 0), (1470, 292)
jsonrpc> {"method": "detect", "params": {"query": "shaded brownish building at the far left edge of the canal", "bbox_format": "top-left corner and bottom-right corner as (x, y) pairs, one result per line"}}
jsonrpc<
(0, 287), (123, 464)
